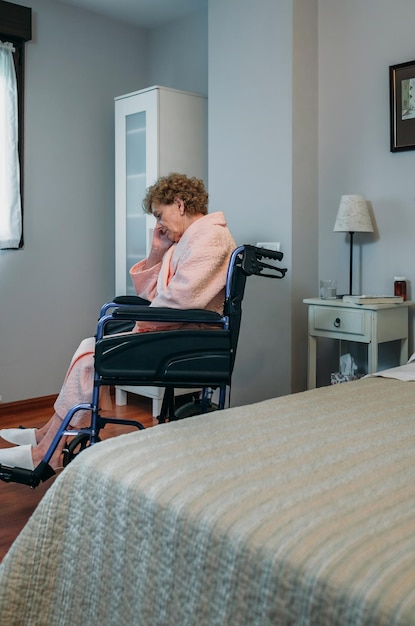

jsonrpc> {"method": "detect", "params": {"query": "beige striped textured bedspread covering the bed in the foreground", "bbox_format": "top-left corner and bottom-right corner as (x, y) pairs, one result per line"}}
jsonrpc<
(0, 378), (415, 626)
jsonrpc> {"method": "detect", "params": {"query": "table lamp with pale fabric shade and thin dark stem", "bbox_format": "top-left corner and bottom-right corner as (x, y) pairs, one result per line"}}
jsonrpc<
(333, 195), (373, 295)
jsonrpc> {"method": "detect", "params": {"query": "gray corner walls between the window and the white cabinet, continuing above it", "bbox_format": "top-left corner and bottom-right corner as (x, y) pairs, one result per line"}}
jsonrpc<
(0, 0), (207, 402)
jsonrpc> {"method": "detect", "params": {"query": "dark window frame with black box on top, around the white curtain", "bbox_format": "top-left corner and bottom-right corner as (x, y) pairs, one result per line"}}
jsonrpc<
(0, 0), (32, 248)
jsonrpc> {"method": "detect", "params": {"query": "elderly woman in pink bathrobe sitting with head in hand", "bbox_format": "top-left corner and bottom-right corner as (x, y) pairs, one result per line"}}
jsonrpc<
(0, 174), (236, 470)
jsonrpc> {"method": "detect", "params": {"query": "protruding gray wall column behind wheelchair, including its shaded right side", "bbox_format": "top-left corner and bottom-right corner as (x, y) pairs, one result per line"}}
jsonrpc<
(209, 0), (318, 404)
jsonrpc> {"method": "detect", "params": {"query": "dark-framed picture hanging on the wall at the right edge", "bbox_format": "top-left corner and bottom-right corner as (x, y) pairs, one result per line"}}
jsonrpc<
(389, 60), (415, 152)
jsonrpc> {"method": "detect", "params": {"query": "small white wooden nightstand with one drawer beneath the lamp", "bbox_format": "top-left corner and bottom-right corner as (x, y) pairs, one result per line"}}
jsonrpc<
(303, 298), (413, 389)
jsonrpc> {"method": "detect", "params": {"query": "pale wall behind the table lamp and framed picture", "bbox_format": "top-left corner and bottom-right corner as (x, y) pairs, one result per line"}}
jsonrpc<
(318, 0), (415, 349)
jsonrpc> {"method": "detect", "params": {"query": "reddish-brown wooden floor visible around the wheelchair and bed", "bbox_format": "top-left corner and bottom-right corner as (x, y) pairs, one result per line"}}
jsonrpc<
(0, 394), (154, 561)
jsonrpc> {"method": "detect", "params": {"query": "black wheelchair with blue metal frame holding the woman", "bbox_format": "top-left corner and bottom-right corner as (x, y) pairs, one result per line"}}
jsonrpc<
(0, 244), (287, 488)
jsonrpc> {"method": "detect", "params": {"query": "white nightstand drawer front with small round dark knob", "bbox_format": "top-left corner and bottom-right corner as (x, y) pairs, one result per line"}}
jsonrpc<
(310, 306), (367, 337)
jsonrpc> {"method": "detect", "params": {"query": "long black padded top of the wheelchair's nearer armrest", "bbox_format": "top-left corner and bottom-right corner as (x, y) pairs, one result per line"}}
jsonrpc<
(112, 306), (222, 324)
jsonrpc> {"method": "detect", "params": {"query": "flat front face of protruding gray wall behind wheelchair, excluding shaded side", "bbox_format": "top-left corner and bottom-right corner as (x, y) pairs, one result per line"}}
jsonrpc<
(209, 0), (292, 405)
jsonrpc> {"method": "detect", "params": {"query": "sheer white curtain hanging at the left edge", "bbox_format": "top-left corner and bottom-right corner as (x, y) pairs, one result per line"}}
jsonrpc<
(0, 42), (22, 249)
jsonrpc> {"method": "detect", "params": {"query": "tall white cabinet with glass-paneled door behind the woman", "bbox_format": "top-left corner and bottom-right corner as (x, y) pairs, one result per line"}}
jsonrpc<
(115, 86), (207, 415)
